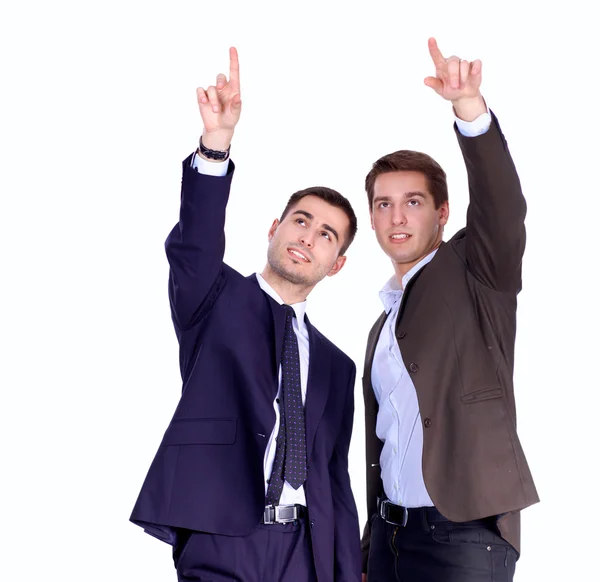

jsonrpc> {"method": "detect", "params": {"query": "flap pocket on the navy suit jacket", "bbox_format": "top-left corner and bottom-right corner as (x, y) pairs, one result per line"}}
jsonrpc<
(162, 418), (237, 446)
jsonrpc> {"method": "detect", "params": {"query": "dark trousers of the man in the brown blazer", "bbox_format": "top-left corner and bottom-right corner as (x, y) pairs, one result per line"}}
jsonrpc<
(367, 508), (518, 582)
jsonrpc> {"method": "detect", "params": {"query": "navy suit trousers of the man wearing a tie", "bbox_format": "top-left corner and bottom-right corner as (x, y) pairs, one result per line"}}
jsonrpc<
(173, 520), (317, 582)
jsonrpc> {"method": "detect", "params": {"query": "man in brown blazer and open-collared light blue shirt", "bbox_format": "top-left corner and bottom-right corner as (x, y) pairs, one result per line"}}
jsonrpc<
(362, 39), (538, 582)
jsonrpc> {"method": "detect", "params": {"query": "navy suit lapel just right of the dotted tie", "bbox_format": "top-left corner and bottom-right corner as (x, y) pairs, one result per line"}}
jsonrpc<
(304, 316), (331, 458)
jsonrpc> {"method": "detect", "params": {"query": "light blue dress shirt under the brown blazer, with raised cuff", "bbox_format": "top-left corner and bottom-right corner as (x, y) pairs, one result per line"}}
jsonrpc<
(371, 111), (491, 507)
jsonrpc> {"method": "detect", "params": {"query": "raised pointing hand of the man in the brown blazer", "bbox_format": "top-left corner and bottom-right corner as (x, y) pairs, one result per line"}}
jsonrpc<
(425, 38), (487, 121)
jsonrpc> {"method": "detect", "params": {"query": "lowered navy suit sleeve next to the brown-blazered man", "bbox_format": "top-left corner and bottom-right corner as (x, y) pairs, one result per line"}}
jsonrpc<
(329, 363), (361, 582)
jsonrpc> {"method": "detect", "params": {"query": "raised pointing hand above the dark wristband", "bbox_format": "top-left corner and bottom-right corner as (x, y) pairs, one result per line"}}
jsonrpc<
(196, 47), (242, 150)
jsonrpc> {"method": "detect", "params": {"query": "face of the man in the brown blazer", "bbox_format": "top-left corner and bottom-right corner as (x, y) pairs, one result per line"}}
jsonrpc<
(371, 172), (449, 275)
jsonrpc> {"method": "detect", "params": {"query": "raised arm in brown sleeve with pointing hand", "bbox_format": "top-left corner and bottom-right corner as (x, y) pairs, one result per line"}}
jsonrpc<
(425, 39), (526, 293)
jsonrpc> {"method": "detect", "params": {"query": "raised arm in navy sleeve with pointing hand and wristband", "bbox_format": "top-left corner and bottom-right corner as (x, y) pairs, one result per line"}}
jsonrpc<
(165, 48), (242, 330)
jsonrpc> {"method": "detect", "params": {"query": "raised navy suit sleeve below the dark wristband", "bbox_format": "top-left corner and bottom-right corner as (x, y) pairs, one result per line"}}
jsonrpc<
(165, 157), (234, 331)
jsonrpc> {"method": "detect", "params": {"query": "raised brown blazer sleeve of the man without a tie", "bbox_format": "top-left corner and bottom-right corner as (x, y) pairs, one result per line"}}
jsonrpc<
(456, 113), (527, 293)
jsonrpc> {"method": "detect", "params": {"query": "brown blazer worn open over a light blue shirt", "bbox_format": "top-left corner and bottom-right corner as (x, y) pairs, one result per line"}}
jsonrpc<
(362, 114), (539, 571)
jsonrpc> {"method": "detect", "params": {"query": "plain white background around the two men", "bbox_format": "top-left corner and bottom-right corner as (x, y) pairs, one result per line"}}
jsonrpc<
(0, 0), (600, 582)
